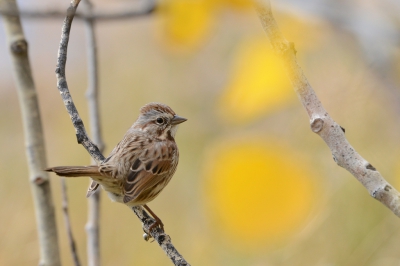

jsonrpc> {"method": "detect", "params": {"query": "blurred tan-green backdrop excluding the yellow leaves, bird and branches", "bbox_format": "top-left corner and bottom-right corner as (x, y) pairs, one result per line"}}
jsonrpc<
(0, 0), (400, 266)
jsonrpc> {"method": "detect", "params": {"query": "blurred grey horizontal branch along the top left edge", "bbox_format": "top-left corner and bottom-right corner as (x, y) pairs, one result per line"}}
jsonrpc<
(0, 0), (156, 21)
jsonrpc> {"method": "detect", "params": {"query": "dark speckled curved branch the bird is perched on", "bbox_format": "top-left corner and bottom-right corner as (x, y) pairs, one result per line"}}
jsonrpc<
(56, 0), (189, 265)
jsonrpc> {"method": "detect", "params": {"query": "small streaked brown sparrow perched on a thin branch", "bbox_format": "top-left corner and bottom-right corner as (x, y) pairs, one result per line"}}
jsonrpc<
(46, 103), (187, 231)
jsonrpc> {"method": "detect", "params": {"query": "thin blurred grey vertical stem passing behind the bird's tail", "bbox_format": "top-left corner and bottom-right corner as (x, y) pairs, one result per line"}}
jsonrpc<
(83, 0), (104, 266)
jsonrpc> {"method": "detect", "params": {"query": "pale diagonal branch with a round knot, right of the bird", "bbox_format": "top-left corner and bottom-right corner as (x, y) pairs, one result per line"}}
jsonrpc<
(256, 0), (400, 217)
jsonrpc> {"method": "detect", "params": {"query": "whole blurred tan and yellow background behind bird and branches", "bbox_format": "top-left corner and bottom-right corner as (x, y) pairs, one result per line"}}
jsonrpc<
(0, 0), (400, 266)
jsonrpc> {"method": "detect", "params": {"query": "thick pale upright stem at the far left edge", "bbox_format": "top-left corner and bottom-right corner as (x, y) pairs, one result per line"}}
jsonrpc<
(0, 0), (60, 265)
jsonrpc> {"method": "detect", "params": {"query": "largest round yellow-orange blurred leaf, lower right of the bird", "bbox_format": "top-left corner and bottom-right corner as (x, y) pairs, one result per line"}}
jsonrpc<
(203, 138), (316, 251)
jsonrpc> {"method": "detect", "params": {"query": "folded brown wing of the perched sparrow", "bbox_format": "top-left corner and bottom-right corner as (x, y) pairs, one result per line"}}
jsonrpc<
(123, 141), (177, 203)
